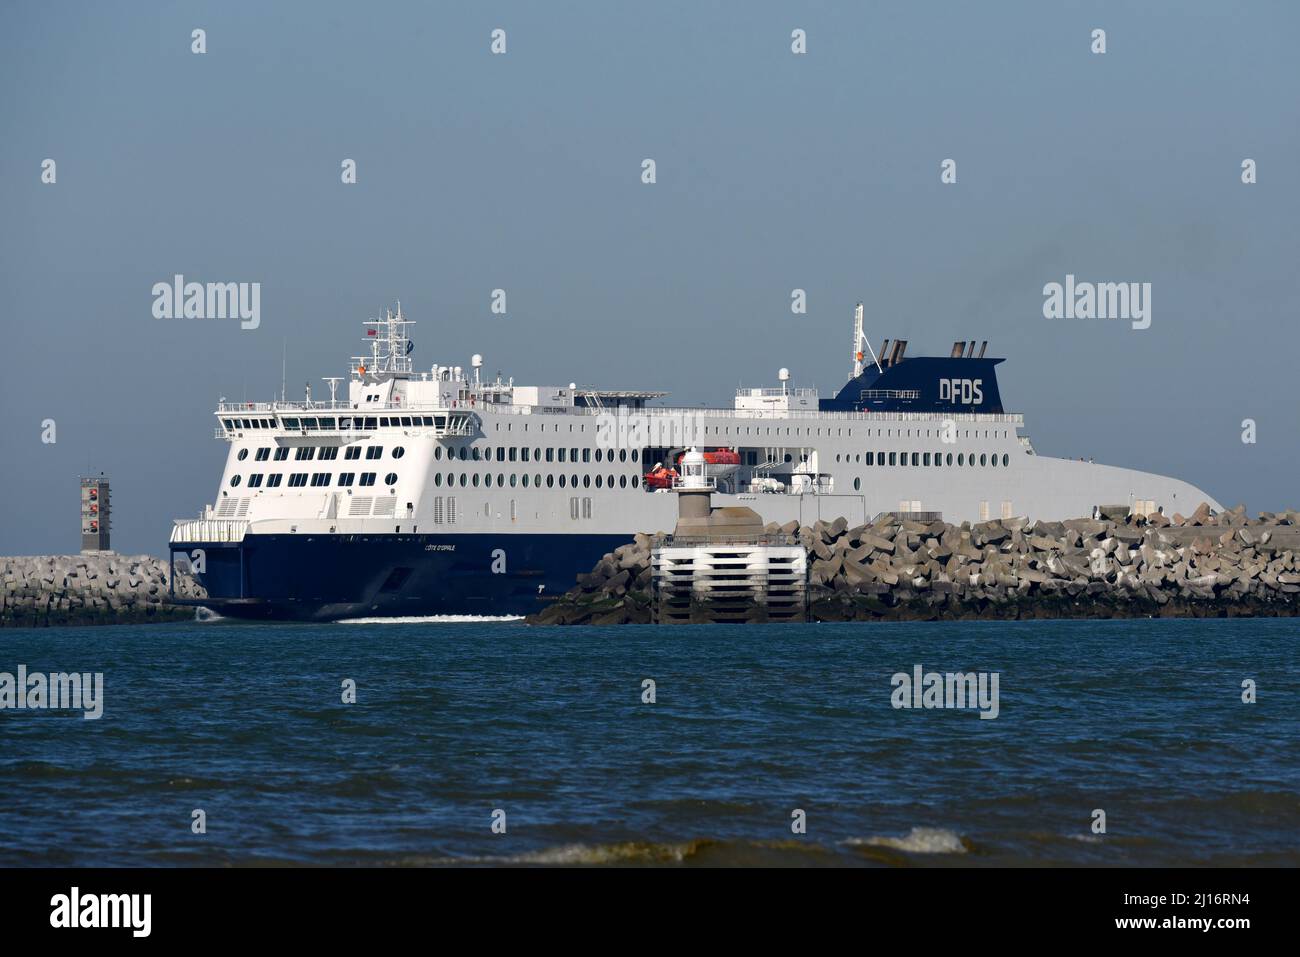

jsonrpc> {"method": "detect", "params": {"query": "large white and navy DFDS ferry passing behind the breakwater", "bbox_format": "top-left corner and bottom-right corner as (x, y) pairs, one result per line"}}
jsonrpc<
(170, 303), (1221, 620)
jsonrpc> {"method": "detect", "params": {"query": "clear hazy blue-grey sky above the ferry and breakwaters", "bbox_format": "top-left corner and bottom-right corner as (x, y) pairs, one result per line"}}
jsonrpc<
(0, 0), (1300, 554)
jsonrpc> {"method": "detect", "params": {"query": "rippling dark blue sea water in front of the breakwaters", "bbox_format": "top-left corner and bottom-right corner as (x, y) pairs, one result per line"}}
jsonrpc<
(0, 619), (1300, 867)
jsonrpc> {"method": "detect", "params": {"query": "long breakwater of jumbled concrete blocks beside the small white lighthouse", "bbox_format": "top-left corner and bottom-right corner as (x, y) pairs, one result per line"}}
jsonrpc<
(528, 505), (1300, 624)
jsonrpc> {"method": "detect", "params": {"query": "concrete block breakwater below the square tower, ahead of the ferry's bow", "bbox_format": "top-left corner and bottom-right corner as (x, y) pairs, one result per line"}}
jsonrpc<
(0, 554), (205, 628)
